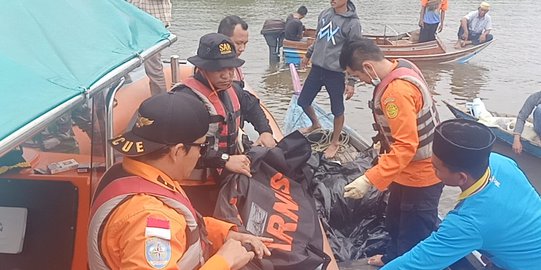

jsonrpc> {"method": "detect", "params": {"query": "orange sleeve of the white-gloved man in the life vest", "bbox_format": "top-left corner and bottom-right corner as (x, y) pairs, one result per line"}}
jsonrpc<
(365, 80), (423, 190)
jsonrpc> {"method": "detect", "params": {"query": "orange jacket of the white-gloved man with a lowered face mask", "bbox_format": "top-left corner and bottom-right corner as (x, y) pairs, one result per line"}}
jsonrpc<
(365, 62), (440, 191)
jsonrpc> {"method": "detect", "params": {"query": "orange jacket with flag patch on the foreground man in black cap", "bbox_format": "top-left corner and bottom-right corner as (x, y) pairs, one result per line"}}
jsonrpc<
(101, 158), (234, 270)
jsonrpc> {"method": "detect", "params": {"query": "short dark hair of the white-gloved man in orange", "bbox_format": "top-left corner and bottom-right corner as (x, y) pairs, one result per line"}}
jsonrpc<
(340, 38), (385, 71)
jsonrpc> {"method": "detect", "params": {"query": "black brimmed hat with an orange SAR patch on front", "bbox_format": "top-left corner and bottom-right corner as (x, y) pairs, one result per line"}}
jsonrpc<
(188, 33), (244, 71)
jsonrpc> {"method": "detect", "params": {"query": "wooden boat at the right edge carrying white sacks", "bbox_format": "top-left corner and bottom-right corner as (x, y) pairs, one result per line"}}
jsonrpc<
(444, 101), (541, 192)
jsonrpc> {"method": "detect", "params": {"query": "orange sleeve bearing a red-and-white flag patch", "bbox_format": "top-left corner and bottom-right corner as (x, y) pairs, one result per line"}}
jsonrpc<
(101, 194), (230, 270)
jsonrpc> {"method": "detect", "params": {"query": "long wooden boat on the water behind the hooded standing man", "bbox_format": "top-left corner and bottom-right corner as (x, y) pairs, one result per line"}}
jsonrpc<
(283, 30), (494, 65)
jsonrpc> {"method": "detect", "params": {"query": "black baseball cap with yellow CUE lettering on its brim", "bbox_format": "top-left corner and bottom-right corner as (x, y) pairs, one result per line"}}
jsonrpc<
(109, 92), (210, 157)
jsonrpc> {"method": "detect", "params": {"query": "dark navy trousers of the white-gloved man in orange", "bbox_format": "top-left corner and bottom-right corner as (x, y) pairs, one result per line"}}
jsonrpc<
(382, 180), (443, 263)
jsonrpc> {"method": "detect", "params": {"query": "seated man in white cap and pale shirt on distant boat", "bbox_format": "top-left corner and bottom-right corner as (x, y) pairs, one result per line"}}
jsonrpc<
(455, 2), (493, 49)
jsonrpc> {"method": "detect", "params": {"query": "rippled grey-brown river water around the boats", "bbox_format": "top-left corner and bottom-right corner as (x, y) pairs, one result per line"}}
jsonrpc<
(164, 0), (541, 215)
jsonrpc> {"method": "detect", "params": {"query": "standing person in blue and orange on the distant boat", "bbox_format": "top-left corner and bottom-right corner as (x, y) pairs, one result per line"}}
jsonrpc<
(419, 0), (449, 42)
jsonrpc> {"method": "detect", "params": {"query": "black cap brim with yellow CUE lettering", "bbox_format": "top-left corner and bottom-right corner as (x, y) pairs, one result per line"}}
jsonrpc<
(109, 131), (166, 157)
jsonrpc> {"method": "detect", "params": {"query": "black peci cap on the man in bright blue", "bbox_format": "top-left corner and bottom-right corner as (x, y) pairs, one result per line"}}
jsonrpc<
(432, 119), (496, 170)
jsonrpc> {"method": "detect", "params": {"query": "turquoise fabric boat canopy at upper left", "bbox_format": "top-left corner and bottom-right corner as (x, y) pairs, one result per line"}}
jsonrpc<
(0, 0), (176, 156)
